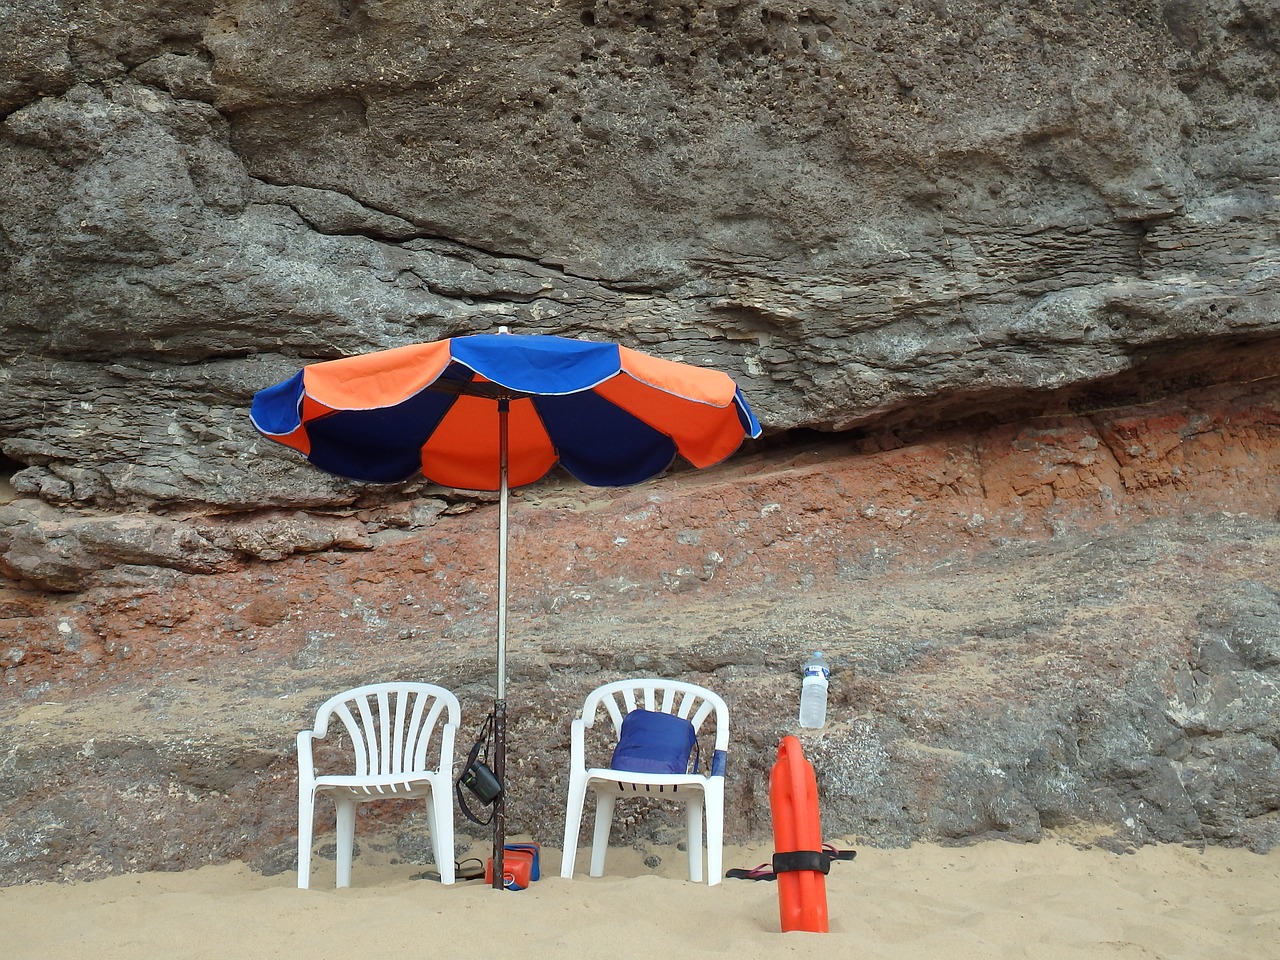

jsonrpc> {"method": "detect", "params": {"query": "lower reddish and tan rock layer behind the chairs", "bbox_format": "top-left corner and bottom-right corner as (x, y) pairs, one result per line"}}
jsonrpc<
(0, 371), (1280, 879)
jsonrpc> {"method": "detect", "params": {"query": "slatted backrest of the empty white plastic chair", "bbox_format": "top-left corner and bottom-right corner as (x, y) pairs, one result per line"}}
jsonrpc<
(315, 682), (461, 777)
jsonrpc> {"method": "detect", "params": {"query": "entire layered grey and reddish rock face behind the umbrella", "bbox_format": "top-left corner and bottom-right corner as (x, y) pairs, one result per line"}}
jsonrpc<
(0, 0), (1280, 882)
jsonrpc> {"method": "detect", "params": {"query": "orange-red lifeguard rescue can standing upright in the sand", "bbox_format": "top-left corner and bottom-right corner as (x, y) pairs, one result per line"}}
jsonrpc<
(769, 736), (828, 933)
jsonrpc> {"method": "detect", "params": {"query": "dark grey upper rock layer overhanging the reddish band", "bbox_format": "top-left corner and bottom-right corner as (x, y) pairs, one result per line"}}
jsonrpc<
(0, 0), (1280, 509)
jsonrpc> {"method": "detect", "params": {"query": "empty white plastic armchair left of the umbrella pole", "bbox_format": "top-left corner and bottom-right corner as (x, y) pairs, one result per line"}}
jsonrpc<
(298, 684), (461, 890)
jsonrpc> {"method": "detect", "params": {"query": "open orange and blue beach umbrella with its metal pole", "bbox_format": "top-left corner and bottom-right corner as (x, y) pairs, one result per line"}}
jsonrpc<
(251, 328), (760, 887)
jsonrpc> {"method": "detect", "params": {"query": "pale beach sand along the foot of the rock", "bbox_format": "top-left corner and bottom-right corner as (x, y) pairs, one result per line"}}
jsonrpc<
(0, 837), (1280, 960)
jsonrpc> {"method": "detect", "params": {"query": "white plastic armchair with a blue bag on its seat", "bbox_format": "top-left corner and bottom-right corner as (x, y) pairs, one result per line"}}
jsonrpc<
(561, 678), (728, 884)
